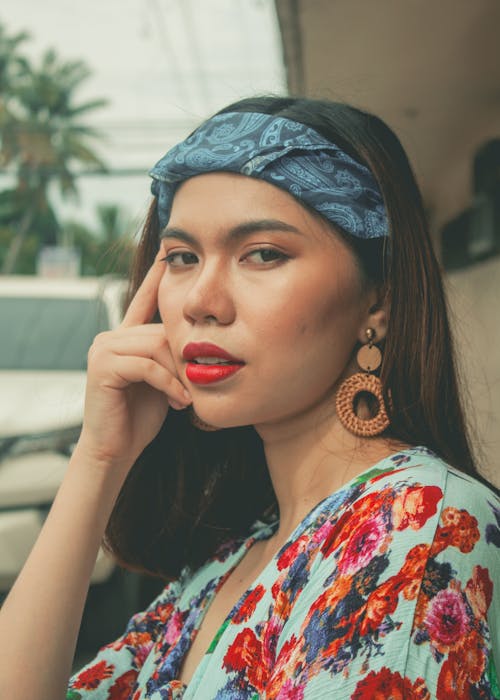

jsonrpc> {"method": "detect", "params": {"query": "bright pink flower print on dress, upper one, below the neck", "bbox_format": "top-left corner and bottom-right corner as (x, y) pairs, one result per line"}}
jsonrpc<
(338, 513), (388, 574)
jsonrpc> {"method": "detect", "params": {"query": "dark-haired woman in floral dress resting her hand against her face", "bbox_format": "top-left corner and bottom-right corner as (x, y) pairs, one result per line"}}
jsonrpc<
(0, 98), (500, 700)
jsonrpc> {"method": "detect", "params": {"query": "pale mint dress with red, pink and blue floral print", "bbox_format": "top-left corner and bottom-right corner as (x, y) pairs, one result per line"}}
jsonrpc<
(67, 447), (500, 700)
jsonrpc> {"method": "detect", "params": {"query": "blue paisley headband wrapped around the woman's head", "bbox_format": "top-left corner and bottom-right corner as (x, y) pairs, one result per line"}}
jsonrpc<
(149, 112), (389, 238)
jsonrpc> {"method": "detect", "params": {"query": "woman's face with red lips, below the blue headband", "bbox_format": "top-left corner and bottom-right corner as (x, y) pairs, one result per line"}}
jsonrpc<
(158, 173), (373, 427)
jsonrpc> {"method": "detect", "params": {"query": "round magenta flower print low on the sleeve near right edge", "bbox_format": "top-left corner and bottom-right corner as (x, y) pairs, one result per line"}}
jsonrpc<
(424, 588), (468, 651)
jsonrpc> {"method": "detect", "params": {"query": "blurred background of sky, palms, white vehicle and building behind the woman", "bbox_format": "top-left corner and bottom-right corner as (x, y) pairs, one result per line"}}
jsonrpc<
(0, 0), (500, 668)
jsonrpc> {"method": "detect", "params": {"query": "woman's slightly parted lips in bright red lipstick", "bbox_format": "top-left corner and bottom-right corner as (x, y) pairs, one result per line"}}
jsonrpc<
(182, 343), (245, 384)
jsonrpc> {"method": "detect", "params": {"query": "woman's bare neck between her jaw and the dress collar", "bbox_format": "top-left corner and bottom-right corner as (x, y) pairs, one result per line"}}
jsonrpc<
(255, 406), (402, 542)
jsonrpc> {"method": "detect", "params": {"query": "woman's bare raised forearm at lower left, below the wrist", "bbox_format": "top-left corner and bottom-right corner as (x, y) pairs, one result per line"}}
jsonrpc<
(0, 448), (129, 700)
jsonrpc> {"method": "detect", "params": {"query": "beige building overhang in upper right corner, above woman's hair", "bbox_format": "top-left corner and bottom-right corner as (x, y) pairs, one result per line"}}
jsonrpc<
(276, 0), (500, 228)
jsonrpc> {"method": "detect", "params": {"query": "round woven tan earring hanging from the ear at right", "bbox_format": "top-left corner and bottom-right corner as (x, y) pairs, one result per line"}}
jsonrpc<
(335, 328), (390, 437)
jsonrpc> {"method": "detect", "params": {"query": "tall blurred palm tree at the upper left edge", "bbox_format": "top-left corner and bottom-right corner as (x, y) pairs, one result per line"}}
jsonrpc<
(0, 37), (106, 274)
